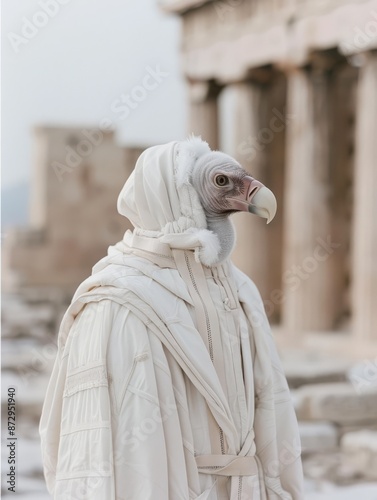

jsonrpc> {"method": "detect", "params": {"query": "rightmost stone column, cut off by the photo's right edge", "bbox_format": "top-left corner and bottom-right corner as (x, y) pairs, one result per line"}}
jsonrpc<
(352, 52), (377, 340)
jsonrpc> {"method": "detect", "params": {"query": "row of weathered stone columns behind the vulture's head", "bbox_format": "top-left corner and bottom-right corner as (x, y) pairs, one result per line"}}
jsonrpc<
(190, 52), (377, 340)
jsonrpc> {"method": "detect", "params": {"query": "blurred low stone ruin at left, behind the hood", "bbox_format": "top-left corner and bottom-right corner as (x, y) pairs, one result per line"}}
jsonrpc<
(4, 127), (143, 297)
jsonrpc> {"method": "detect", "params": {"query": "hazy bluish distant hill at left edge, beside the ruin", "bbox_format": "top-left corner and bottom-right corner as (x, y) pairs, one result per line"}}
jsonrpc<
(1, 181), (29, 230)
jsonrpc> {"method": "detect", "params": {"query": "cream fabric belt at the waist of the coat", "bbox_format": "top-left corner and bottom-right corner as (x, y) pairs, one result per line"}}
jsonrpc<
(196, 455), (258, 476)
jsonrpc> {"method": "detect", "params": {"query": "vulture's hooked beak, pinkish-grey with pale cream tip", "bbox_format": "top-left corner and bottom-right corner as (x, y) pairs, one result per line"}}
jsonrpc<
(227, 175), (277, 224)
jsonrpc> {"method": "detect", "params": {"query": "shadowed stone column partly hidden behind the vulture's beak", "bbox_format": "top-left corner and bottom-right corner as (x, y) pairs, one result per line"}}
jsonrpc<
(228, 74), (286, 322)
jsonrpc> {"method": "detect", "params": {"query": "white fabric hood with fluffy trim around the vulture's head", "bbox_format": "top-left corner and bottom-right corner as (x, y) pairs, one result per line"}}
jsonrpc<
(117, 137), (220, 266)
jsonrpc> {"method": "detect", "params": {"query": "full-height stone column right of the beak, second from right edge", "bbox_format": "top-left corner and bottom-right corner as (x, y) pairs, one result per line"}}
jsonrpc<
(282, 62), (341, 335)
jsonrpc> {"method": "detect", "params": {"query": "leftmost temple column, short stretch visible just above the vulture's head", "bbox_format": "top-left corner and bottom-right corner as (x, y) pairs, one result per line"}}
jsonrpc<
(189, 82), (220, 149)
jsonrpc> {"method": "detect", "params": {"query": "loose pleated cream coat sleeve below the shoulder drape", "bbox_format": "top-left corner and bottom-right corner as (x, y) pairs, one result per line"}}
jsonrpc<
(40, 299), (183, 500)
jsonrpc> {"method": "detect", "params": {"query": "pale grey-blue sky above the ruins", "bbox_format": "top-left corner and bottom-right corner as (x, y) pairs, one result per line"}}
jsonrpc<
(2, 0), (186, 188)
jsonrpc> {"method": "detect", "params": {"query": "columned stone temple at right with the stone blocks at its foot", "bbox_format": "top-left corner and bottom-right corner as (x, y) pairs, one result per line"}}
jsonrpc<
(160, 0), (377, 488)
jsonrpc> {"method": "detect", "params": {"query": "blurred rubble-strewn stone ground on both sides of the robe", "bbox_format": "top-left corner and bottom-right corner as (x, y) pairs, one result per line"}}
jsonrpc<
(1, 297), (377, 500)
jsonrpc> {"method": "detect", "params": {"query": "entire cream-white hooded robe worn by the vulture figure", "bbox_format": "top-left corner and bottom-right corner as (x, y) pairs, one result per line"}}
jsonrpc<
(40, 141), (303, 500)
